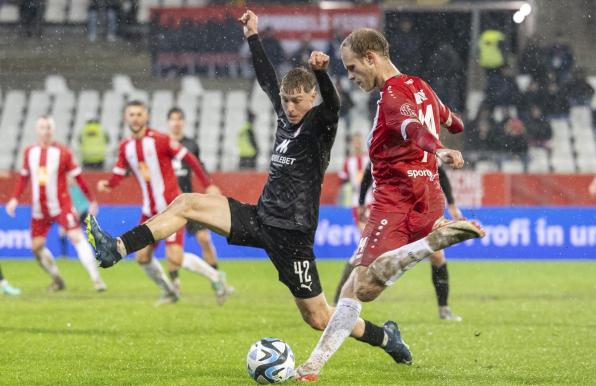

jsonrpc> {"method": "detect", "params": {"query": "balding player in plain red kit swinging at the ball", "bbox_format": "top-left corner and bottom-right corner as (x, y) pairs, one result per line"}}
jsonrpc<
(295, 28), (484, 381)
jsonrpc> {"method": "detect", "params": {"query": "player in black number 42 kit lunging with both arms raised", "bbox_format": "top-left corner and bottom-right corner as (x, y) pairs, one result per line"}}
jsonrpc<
(87, 11), (411, 363)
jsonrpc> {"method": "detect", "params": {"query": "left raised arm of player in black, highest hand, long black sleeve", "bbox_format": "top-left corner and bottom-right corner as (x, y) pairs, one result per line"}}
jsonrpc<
(239, 10), (283, 116)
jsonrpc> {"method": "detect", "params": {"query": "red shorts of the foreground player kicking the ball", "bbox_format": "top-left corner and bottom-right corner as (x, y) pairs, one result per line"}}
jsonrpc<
(352, 209), (443, 267)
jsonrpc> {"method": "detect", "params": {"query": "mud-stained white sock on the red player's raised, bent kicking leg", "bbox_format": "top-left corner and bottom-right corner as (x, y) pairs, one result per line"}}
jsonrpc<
(378, 238), (435, 286)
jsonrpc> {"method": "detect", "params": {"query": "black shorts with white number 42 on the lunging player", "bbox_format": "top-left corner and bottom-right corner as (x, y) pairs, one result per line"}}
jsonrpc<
(228, 198), (323, 299)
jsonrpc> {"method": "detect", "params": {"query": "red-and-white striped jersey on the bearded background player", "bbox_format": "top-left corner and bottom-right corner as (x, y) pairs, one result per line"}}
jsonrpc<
(108, 128), (188, 216)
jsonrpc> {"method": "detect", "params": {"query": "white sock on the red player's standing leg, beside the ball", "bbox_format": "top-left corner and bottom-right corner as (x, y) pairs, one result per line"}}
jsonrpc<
(303, 298), (362, 374)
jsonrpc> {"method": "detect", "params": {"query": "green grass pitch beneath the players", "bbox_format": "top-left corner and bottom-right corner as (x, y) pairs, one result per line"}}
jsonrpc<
(0, 261), (596, 385)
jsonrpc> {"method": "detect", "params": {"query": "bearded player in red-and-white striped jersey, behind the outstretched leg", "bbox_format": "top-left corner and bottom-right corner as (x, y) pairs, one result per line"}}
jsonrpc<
(97, 101), (219, 305)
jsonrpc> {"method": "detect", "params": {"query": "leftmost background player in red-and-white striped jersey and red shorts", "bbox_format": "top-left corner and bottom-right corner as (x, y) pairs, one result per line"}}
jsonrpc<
(6, 116), (106, 292)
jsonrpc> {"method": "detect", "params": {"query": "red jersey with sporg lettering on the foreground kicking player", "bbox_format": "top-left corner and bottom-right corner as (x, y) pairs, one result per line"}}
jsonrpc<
(368, 74), (451, 212)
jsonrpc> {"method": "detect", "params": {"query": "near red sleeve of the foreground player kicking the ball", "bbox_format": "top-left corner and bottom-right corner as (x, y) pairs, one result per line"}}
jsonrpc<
(383, 91), (443, 153)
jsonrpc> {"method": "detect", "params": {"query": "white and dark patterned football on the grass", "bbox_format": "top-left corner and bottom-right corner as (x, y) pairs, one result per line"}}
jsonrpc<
(246, 338), (294, 384)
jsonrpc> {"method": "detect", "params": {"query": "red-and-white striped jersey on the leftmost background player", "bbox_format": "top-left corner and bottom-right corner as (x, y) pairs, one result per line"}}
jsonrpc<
(15, 142), (81, 219)
